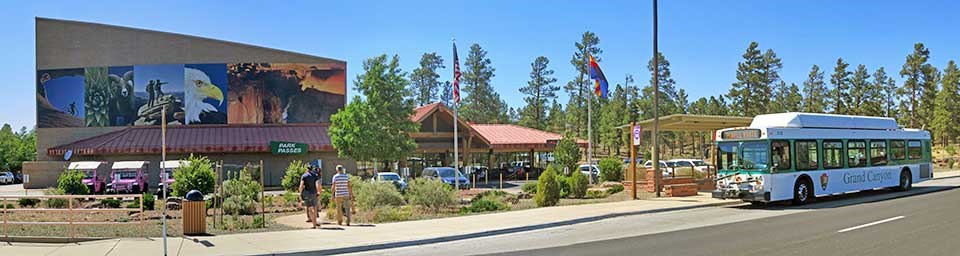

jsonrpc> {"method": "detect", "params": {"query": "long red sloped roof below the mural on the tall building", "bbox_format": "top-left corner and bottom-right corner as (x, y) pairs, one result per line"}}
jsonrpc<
(47, 124), (333, 156)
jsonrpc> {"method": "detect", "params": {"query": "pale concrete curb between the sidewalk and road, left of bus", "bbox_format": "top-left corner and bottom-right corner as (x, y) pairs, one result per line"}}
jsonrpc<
(264, 201), (744, 255)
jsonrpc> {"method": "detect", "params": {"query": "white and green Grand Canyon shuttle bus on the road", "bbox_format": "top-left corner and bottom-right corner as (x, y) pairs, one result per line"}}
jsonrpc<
(712, 113), (933, 204)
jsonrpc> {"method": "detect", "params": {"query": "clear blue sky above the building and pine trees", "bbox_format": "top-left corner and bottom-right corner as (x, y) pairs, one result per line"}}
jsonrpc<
(0, 0), (960, 130)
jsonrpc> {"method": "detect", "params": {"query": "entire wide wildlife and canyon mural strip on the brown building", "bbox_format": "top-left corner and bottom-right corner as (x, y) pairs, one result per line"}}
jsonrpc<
(37, 63), (347, 128)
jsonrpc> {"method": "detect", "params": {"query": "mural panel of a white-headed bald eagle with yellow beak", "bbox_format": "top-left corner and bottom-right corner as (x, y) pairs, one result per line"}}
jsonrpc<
(183, 64), (227, 124)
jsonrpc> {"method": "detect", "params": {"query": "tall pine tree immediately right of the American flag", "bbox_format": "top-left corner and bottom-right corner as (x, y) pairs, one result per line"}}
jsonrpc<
(460, 44), (508, 123)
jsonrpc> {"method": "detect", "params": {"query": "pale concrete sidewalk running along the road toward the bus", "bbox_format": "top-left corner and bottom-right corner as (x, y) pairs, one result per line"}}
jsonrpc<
(0, 171), (960, 256)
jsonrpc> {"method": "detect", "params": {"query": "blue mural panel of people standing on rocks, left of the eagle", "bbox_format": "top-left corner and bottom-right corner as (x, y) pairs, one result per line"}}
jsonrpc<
(133, 64), (186, 125)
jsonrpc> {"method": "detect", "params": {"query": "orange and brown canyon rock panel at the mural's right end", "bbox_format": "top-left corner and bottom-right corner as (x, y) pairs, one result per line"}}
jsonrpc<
(227, 63), (346, 124)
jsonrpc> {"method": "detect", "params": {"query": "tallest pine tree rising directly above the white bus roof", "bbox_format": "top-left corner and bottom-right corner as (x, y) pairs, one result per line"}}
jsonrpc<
(727, 42), (783, 116)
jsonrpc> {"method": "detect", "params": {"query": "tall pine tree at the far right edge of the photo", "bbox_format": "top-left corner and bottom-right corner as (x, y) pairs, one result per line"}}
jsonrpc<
(931, 60), (960, 146)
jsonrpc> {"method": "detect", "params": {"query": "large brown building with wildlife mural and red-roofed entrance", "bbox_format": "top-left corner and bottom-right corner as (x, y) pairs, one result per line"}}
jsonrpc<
(24, 18), (584, 188)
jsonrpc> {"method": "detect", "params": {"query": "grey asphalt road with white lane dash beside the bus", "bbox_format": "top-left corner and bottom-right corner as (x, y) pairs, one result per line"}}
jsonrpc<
(499, 185), (960, 255)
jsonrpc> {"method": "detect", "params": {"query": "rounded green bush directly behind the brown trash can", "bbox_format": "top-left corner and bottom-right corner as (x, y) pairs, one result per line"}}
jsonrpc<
(171, 155), (216, 197)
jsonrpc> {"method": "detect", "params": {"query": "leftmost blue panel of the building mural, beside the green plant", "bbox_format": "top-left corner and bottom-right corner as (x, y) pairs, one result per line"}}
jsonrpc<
(37, 68), (86, 128)
